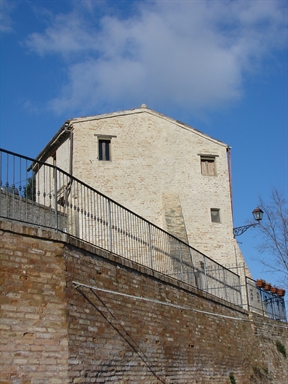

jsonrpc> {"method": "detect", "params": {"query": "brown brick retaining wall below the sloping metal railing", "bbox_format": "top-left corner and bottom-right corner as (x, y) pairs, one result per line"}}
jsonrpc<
(0, 221), (288, 384)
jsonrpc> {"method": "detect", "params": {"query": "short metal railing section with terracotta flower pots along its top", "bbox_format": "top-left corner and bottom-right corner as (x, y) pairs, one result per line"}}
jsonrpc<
(246, 277), (287, 321)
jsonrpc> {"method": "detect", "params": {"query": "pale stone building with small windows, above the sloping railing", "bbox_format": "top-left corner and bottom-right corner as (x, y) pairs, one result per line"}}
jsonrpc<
(37, 105), (248, 272)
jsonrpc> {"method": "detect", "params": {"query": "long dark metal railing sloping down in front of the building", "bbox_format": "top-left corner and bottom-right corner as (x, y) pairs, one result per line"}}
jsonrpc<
(0, 149), (242, 306)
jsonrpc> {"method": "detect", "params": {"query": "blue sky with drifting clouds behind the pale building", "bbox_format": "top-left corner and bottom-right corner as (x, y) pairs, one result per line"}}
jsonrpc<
(0, 0), (288, 282)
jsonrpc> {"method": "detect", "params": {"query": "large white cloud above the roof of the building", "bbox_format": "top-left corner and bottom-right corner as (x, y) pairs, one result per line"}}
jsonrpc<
(27, 0), (287, 113)
